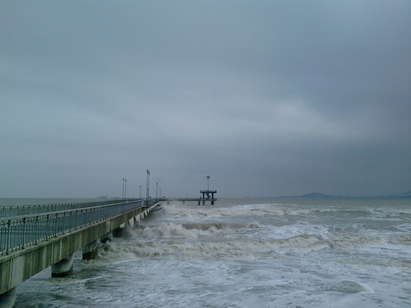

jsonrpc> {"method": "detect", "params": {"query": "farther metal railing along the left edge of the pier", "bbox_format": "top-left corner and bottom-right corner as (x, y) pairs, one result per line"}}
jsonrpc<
(0, 199), (139, 219)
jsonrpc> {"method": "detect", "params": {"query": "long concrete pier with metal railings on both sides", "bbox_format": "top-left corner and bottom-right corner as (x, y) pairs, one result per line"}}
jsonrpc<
(0, 199), (160, 308)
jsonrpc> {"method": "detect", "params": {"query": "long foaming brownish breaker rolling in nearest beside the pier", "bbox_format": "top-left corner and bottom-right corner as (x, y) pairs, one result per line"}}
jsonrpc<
(99, 223), (381, 258)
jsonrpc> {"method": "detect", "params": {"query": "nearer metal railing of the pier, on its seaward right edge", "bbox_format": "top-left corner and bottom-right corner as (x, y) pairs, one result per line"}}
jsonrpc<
(0, 200), (148, 255)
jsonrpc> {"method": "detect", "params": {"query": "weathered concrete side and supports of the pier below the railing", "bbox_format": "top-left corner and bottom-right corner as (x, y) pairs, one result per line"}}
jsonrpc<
(0, 203), (159, 308)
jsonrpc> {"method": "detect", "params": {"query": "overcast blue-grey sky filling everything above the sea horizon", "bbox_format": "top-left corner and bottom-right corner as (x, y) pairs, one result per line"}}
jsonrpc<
(0, 0), (411, 197)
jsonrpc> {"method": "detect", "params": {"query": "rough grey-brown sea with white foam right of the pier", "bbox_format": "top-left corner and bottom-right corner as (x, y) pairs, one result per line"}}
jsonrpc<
(5, 198), (411, 308)
